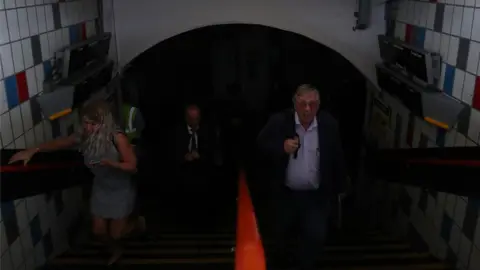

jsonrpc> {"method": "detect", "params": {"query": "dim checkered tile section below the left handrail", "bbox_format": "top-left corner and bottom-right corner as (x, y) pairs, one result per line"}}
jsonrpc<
(0, 187), (82, 270)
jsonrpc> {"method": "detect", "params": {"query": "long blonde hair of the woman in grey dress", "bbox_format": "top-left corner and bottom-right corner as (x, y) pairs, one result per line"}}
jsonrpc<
(78, 100), (118, 156)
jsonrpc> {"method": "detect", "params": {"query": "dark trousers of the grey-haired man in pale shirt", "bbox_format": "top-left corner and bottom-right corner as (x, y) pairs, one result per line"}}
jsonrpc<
(267, 187), (330, 270)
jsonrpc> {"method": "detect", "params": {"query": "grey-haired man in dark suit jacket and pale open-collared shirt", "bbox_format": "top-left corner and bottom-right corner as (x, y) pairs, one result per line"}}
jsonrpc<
(258, 85), (347, 270)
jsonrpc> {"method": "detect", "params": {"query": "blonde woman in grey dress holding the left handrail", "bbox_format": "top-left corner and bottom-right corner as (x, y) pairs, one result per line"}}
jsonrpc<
(10, 101), (145, 264)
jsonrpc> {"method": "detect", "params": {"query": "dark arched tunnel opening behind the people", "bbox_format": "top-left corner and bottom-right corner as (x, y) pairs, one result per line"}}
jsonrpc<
(123, 24), (366, 179)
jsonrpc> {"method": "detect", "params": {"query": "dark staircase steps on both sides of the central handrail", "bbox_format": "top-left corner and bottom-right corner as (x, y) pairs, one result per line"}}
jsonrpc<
(42, 169), (453, 270)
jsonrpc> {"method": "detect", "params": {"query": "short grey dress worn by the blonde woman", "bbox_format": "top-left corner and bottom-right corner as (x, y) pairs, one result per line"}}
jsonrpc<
(79, 133), (136, 219)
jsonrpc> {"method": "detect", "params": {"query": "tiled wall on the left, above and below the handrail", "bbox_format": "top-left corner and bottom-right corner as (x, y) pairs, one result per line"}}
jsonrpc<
(0, 0), (98, 270)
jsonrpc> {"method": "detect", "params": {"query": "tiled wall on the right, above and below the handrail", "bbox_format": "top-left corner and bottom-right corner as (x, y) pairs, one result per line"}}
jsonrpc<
(370, 0), (480, 270)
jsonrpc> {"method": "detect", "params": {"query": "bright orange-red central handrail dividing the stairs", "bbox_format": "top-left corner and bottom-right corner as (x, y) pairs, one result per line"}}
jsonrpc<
(235, 171), (266, 270)
